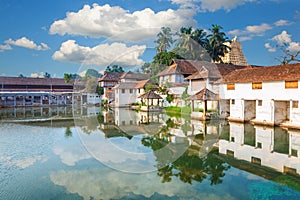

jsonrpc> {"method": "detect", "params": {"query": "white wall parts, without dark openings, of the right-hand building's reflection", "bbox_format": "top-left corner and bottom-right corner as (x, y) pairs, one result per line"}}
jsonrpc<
(219, 123), (300, 174)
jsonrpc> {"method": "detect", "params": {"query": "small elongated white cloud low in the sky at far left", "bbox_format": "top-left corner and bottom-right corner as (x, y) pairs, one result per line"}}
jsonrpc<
(5, 37), (50, 51)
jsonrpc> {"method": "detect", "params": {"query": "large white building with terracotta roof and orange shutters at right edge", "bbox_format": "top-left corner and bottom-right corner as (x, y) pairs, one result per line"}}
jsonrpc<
(220, 63), (300, 128)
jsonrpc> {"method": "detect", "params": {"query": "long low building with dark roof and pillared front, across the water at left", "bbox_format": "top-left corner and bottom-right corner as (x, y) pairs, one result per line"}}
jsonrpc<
(0, 77), (101, 107)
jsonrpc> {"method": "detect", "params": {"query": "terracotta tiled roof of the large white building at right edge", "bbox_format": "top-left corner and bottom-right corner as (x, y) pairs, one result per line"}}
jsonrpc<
(221, 63), (300, 83)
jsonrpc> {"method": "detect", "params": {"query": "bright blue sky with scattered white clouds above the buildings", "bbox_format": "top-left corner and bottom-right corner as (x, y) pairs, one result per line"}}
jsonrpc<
(0, 0), (300, 77)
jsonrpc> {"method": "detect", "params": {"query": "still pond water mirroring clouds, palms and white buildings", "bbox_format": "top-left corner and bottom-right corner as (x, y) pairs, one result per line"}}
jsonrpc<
(0, 107), (300, 199)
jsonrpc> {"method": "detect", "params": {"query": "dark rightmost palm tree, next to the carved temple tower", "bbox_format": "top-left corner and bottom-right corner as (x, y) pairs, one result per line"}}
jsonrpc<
(206, 24), (230, 63)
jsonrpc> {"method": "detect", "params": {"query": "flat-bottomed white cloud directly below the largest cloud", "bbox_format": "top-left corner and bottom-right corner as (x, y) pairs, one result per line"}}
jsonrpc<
(52, 40), (146, 66)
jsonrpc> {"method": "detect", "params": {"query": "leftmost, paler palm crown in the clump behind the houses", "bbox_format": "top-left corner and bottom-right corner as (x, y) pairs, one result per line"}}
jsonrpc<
(155, 27), (174, 53)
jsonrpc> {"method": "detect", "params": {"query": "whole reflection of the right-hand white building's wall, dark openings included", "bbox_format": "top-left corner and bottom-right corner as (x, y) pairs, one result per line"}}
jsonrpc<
(219, 122), (300, 176)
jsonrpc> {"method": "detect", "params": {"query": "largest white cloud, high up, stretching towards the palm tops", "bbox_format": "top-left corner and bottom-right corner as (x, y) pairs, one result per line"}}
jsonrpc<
(50, 4), (197, 42)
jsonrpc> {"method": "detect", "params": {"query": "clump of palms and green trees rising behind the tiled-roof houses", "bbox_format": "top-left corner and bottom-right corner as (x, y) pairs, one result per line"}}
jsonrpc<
(141, 25), (230, 83)
